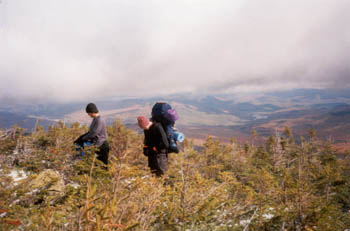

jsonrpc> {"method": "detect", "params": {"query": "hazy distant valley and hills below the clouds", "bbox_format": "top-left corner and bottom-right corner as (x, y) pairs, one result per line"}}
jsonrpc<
(0, 89), (350, 148)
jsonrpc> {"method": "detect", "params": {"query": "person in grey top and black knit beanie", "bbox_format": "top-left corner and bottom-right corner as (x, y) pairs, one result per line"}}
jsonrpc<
(74, 103), (109, 165)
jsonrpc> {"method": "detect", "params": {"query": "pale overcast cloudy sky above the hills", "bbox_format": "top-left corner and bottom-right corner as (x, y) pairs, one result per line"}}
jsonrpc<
(0, 0), (350, 101)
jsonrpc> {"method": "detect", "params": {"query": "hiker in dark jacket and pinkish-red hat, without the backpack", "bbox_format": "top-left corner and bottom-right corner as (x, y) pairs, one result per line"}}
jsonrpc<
(137, 116), (169, 176)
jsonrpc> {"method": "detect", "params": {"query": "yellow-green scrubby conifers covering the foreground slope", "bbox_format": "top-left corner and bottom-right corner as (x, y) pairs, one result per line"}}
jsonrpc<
(0, 121), (350, 231)
